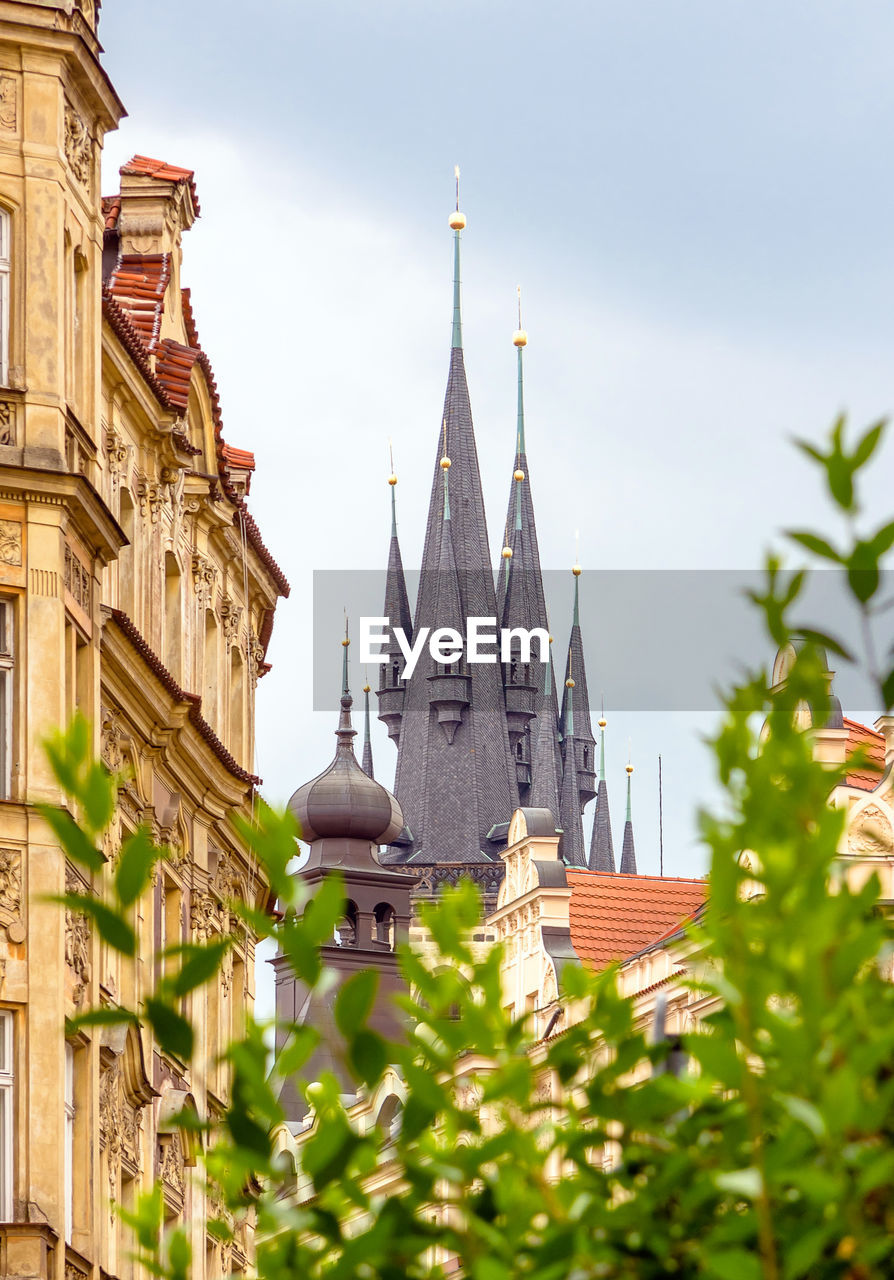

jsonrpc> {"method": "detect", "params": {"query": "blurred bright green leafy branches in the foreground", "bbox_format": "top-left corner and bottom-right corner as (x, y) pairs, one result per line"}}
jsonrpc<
(45, 421), (894, 1280)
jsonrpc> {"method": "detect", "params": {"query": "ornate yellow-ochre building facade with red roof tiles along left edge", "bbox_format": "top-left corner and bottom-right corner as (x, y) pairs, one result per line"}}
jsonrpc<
(0, 0), (288, 1280)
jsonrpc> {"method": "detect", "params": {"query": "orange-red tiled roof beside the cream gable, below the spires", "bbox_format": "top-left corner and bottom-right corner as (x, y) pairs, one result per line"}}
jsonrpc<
(566, 868), (708, 968)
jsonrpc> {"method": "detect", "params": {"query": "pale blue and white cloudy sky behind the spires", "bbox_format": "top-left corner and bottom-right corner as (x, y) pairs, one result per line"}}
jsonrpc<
(100, 0), (894, 901)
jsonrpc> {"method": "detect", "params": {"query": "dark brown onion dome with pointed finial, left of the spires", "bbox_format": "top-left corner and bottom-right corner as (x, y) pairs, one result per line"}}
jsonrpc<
(288, 648), (403, 845)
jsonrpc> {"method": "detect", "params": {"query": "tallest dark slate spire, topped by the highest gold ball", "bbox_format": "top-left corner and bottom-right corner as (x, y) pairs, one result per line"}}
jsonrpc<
(392, 197), (519, 867)
